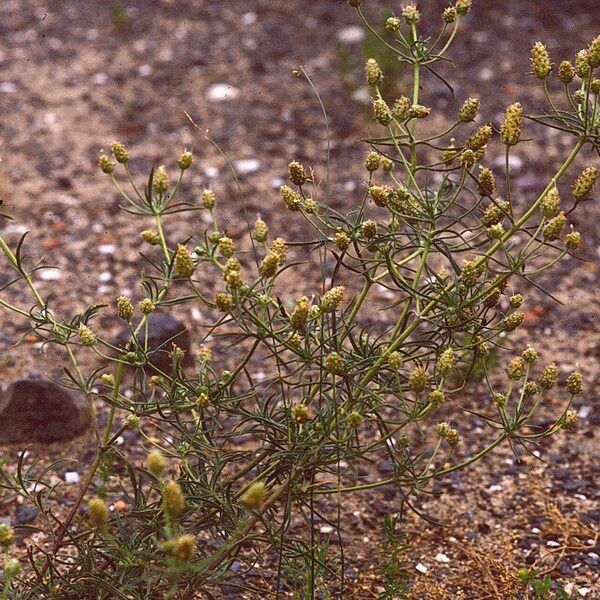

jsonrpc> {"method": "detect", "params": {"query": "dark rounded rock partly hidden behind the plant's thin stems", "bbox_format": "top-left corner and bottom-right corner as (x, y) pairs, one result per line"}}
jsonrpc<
(117, 312), (191, 372)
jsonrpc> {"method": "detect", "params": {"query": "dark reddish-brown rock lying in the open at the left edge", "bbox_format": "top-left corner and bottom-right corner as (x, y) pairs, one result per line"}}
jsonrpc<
(0, 374), (92, 444)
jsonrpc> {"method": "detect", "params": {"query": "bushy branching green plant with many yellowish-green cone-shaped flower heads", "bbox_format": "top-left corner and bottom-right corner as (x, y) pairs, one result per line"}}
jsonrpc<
(0, 0), (600, 598)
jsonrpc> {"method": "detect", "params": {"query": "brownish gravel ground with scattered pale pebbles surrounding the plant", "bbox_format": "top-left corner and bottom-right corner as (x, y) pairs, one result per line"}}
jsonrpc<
(0, 0), (600, 599)
